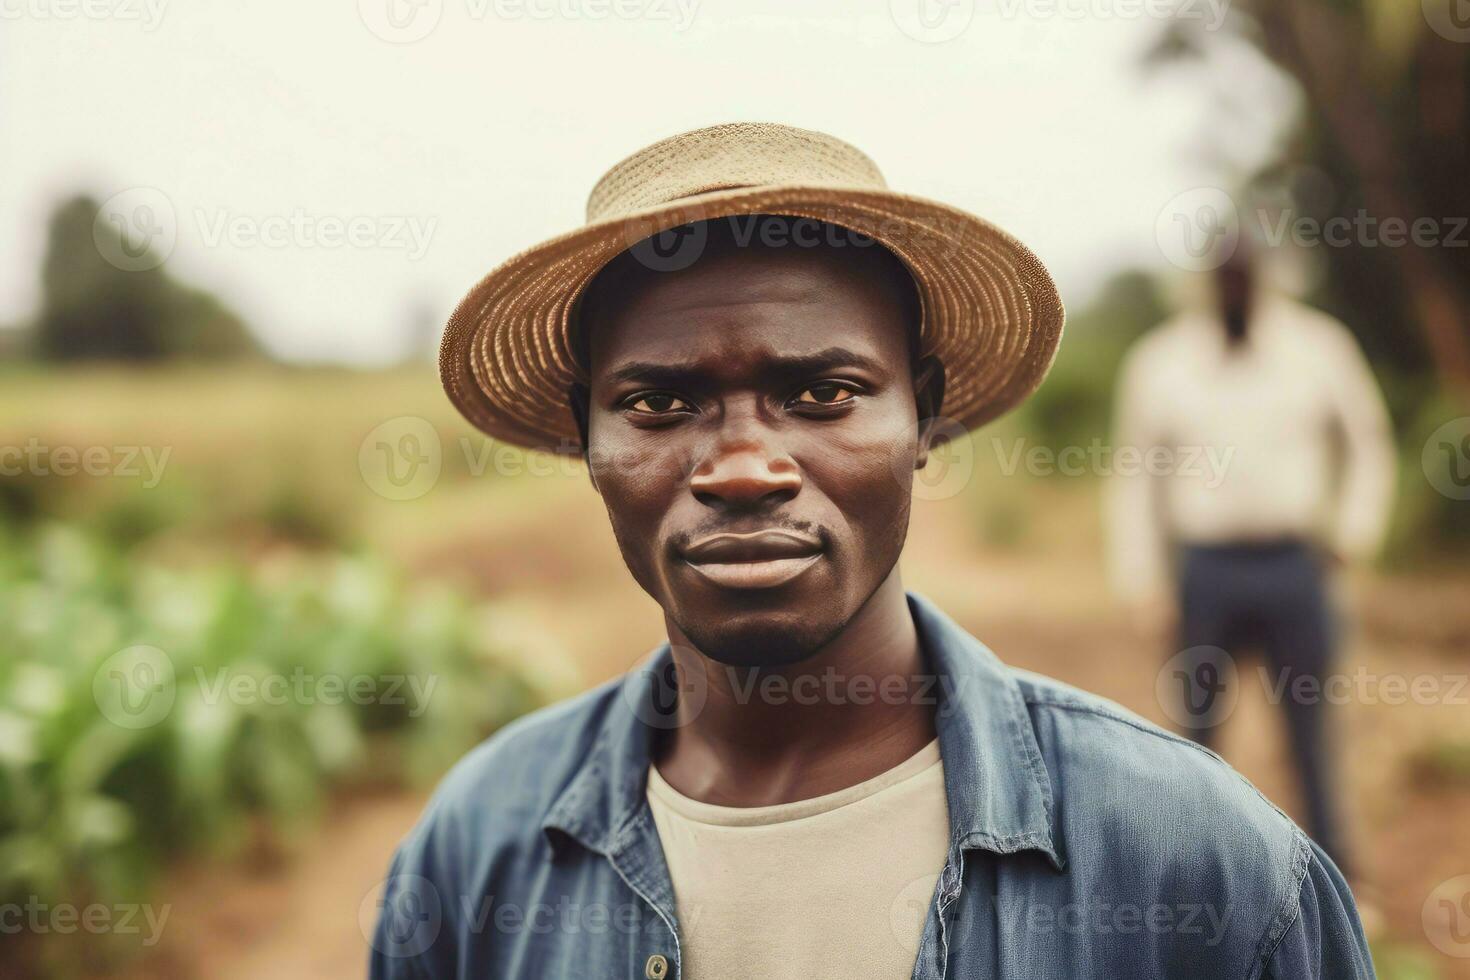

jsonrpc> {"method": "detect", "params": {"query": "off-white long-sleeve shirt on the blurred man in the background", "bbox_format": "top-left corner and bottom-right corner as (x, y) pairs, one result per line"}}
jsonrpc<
(1107, 295), (1394, 599)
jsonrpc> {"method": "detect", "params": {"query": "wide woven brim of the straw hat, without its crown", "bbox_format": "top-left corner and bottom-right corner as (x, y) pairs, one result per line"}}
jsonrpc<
(440, 185), (1064, 453)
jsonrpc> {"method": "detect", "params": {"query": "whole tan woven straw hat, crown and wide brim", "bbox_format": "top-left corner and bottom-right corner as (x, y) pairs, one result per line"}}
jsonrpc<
(440, 123), (1063, 453)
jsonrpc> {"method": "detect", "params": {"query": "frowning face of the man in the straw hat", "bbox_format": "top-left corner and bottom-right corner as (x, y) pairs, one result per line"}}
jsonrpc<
(588, 239), (928, 666)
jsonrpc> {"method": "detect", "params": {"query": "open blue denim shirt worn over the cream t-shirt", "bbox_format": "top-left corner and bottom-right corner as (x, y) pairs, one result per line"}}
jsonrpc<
(370, 594), (1373, 980)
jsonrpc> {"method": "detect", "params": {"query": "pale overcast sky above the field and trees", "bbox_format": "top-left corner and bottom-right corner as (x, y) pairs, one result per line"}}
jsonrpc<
(0, 0), (1291, 363)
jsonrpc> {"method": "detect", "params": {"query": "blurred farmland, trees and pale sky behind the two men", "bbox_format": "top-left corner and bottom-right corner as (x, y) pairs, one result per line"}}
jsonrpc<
(0, 0), (1470, 980)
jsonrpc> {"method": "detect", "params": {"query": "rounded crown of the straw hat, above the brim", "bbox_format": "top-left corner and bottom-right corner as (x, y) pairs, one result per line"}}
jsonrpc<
(587, 122), (888, 223)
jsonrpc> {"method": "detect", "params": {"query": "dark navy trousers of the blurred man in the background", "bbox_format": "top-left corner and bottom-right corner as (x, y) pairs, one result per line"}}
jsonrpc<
(1179, 541), (1348, 871)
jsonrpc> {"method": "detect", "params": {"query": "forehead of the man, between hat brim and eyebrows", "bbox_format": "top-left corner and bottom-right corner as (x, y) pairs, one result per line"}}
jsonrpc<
(587, 248), (910, 382)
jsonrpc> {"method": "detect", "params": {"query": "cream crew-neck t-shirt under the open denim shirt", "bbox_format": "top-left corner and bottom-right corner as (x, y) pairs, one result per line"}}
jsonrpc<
(648, 739), (950, 980)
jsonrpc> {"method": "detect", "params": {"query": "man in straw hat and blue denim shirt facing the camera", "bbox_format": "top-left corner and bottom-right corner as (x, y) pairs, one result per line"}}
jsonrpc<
(370, 123), (1373, 980)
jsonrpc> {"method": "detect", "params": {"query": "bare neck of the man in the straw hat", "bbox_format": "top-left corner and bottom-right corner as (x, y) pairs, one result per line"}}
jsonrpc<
(656, 566), (935, 807)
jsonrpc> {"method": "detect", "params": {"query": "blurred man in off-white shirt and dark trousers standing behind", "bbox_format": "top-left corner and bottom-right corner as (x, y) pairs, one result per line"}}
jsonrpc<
(1108, 241), (1394, 877)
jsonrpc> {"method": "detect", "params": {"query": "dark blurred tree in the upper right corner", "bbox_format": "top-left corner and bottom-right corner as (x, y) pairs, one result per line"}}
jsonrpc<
(1150, 0), (1470, 411)
